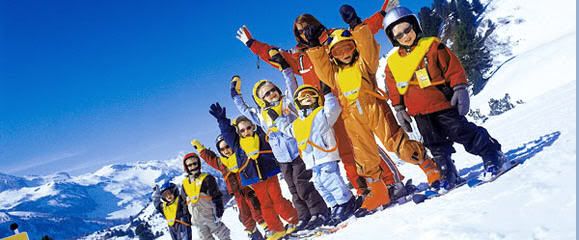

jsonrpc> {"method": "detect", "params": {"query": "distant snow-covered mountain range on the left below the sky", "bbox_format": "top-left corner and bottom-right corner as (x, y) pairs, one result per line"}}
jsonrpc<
(0, 154), (229, 239)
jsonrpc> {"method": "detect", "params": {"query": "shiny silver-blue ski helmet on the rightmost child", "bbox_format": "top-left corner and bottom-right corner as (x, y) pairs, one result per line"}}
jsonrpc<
(382, 7), (422, 47)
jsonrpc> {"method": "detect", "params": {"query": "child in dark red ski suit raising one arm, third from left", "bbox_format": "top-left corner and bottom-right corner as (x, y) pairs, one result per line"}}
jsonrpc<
(191, 135), (265, 240)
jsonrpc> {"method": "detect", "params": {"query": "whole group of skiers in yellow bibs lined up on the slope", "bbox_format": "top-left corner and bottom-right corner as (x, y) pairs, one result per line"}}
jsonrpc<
(154, 0), (504, 239)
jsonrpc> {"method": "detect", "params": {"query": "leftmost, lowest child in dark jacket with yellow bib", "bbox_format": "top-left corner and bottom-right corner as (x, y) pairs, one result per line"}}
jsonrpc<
(152, 182), (192, 240)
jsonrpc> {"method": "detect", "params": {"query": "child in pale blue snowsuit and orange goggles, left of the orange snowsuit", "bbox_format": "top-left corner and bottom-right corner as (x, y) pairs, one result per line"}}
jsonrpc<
(276, 82), (355, 223)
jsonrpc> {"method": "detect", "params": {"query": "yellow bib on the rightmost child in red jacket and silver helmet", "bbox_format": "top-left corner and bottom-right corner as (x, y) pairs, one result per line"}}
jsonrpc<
(387, 37), (439, 95)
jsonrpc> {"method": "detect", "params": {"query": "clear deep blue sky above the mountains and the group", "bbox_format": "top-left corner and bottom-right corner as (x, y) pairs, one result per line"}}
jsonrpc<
(0, 0), (431, 175)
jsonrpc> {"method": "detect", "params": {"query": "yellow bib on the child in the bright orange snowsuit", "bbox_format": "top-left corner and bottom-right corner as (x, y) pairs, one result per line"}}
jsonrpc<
(337, 63), (362, 104)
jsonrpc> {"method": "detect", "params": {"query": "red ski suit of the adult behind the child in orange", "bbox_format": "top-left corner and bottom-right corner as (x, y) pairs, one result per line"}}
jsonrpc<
(250, 12), (404, 191)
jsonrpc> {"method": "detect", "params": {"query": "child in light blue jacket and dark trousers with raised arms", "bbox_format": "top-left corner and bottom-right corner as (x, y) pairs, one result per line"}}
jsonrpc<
(231, 49), (330, 231)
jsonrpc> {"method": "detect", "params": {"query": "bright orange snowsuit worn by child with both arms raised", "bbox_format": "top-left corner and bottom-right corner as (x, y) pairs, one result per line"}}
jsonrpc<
(307, 24), (426, 179)
